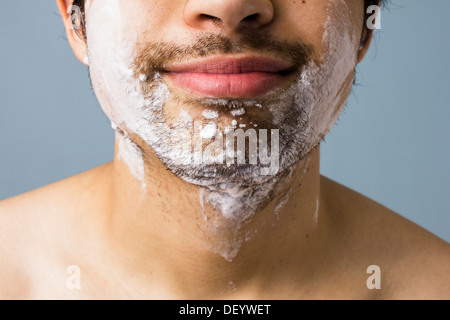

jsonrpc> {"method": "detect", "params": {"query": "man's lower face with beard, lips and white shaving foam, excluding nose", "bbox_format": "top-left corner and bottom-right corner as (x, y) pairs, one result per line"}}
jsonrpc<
(86, 0), (363, 250)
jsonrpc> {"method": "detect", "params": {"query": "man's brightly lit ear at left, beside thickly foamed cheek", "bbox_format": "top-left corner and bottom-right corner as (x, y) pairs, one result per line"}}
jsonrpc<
(56, 0), (88, 65)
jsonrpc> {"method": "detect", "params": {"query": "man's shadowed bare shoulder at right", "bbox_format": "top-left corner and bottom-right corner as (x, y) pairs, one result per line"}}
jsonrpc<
(321, 177), (450, 299)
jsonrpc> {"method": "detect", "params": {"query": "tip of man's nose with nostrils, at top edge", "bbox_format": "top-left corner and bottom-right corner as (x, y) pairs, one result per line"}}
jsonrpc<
(184, 0), (274, 32)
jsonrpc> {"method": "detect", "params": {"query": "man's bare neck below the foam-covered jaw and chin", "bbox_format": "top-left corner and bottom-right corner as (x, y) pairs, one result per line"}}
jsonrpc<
(100, 137), (326, 298)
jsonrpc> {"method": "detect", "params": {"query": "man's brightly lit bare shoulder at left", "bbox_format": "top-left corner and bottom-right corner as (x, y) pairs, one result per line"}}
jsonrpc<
(0, 165), (109, 299)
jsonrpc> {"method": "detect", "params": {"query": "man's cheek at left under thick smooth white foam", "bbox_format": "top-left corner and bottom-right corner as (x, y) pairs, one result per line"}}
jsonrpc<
(86, 0), (141, 129)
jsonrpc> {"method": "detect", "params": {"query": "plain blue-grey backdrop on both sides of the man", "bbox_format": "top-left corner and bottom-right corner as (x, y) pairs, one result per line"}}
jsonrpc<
(0, 0), (450, 241)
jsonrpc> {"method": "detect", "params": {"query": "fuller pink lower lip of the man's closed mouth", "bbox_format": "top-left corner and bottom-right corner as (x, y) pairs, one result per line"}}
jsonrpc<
(167, 72), (288, 98)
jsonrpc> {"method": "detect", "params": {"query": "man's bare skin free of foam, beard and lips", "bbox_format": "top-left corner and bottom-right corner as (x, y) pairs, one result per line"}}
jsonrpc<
(0, 0), (450, 299)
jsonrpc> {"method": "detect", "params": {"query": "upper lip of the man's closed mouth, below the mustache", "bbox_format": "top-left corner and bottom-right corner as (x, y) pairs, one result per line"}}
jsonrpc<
(164, 56), (295, 74)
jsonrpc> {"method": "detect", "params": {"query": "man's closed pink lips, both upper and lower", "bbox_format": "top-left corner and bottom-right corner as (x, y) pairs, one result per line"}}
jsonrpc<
(164, 56), (295, 98)
